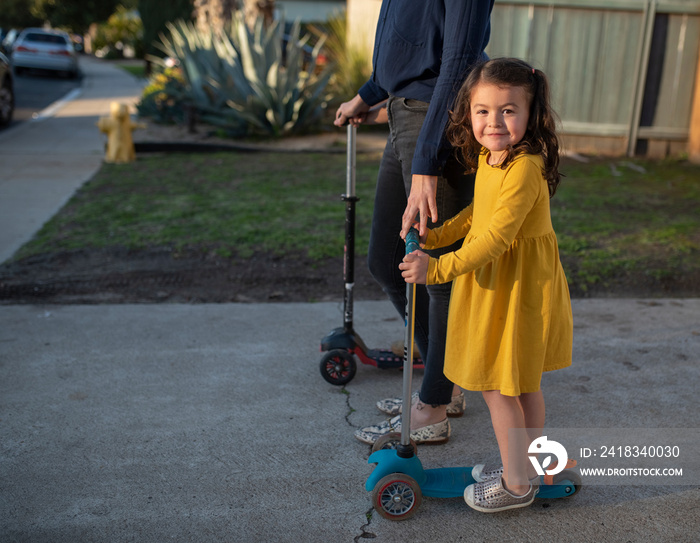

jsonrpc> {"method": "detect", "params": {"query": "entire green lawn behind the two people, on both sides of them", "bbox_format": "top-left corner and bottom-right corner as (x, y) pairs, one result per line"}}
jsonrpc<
(16, 152), (700, 295)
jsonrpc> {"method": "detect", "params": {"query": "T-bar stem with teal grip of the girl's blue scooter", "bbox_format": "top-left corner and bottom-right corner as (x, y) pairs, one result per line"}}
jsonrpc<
(396, 228), (420, 458)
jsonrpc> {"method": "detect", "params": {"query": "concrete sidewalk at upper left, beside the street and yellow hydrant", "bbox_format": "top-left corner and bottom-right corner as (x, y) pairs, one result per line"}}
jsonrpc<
(0, 56), (143, 262)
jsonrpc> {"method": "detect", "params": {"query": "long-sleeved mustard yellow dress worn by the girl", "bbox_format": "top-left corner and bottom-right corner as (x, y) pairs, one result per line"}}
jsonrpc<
(425, 153), (573, 396)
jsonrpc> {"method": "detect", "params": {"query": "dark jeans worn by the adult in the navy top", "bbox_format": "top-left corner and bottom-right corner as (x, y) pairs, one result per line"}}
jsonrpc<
(368, 97), (474, 405)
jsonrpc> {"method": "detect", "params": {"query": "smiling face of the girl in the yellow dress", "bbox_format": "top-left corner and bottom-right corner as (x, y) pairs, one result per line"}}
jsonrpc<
(470, 83), (530, 165)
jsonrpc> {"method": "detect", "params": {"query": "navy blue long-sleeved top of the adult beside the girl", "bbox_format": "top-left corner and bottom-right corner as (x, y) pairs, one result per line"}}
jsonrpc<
(359, 0), (494, 175)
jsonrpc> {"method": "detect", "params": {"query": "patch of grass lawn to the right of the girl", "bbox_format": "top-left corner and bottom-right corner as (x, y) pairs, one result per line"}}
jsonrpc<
(552, 159), (700, 292)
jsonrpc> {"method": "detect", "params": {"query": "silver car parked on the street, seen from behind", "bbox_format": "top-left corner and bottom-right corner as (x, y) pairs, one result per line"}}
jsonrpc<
(12, 28), (78, 77)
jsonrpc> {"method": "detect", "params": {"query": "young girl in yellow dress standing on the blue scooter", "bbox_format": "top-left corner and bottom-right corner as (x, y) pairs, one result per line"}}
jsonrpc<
(399, 59), (573, 512)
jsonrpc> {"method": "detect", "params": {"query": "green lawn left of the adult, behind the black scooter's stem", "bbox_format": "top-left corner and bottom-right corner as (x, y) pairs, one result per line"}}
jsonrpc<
(18, 153), (379, 258)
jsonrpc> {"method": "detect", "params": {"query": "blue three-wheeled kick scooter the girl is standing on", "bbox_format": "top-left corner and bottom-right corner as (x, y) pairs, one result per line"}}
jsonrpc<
(365, 228), (581, 520)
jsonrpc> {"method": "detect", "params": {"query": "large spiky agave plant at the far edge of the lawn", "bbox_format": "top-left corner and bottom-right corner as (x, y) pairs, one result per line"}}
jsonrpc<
(153, 12), (332, 136)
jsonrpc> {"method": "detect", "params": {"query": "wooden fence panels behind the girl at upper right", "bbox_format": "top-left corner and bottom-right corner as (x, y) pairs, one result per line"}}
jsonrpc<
(487, 0), (700, 157)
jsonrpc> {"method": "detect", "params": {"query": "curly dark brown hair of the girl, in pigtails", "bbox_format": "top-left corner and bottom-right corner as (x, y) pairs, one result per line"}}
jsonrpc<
(447, 58), (561, 198)
